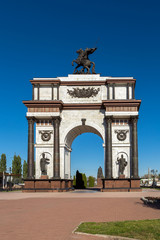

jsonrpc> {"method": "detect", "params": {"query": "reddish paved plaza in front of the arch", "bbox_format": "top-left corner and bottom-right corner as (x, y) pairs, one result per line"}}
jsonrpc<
(0, 190), (160, 240)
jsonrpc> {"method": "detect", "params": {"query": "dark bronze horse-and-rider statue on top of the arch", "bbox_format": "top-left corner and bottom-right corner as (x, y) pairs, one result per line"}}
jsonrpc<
(72, 48), (97, 74)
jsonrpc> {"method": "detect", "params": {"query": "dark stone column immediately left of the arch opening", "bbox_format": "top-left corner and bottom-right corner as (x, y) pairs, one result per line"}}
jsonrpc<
(53, 117), (61, 179)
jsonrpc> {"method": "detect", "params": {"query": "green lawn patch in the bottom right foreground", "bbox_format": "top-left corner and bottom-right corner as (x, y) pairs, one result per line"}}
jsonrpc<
(76, 219), (160, 240)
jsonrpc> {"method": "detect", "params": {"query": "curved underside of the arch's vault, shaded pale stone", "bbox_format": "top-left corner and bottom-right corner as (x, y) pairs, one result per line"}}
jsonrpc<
(64, 125), (103, 148)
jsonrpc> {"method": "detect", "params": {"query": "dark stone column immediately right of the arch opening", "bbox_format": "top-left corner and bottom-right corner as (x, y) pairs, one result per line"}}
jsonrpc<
(105, 116), (112, 178)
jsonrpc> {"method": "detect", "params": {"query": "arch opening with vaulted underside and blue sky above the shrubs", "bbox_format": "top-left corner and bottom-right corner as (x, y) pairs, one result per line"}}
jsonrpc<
(65, 125), (104, 181)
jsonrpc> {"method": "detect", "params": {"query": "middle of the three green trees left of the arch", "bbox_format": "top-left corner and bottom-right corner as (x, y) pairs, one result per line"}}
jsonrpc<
(12, 155), (22, 183)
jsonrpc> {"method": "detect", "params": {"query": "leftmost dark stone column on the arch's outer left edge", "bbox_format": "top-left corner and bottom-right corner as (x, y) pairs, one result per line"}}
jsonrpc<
(27, 117), (34, 178)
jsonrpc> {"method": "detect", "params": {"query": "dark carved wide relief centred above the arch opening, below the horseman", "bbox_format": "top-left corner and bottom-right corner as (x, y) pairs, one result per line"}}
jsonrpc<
(67, 87), (100, 98)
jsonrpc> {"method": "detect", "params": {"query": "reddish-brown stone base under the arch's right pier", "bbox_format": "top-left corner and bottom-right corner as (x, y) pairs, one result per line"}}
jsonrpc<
(101, 178), (142, 192)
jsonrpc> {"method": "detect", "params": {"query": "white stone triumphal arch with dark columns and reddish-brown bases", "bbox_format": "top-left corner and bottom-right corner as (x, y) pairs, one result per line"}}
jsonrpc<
(23, 47), (141, 191)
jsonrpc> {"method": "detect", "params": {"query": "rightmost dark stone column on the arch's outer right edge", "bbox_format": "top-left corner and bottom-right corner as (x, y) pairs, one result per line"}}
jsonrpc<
(131, 116), (139, 178)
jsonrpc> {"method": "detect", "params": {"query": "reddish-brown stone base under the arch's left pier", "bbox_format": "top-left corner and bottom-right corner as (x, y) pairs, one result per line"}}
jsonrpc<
(23, 179), (73, 192)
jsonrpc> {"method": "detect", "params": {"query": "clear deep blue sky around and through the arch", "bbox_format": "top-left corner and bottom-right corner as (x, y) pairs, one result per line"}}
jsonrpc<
(0, 0), (160, 175)
